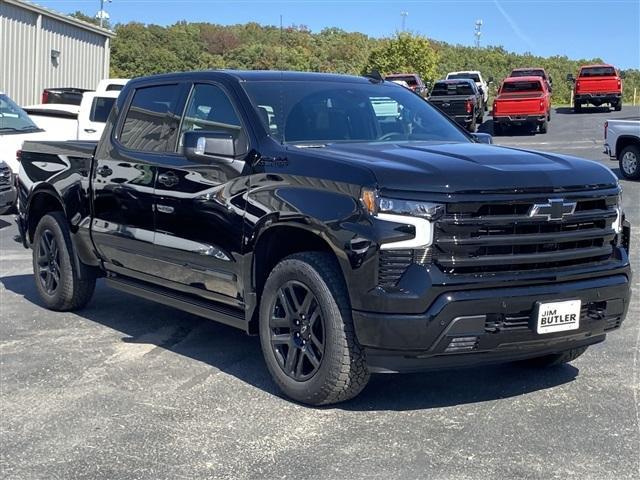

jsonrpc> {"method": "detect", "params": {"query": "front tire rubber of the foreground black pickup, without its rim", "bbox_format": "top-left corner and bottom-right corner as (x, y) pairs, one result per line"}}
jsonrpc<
(259, 252), (369, 405)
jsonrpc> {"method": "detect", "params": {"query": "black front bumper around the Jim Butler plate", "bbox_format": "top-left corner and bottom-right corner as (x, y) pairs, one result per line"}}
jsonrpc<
(353, 274), (631, 372)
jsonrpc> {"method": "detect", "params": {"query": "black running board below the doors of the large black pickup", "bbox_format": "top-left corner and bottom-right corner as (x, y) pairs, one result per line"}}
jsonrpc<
(106, 277), (247, 331)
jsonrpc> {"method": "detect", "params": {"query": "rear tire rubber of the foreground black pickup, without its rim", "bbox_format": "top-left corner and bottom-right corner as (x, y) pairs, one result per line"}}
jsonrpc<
(32, 212), (96, 312)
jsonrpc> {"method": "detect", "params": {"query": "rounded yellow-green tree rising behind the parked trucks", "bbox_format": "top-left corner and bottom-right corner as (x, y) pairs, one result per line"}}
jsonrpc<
(362, 33), (439, 82)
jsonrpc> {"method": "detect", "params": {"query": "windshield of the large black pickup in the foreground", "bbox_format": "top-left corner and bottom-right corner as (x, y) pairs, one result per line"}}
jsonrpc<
(244, 81), (471, 146)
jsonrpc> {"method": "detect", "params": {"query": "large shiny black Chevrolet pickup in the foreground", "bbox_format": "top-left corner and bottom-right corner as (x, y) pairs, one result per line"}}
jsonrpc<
(18, 71), (631, 405)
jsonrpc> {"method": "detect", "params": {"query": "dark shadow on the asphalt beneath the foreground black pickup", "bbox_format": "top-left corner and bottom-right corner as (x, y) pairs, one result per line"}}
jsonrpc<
(0, 275), (578, 411)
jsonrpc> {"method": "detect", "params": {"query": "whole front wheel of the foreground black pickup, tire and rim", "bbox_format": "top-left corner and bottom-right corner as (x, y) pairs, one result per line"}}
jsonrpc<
(259, 252), (369, 405)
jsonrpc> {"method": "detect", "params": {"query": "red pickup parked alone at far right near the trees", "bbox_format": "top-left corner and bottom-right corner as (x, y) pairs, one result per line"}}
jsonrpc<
(567, 65), (622, 113)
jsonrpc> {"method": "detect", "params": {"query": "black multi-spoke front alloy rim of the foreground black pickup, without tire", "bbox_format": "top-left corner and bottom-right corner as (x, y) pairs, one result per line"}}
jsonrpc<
(269, 280), (325, 382)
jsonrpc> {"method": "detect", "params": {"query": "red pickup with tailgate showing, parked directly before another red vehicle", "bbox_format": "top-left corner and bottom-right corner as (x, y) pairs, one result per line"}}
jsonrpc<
(492, 76), (551, 135)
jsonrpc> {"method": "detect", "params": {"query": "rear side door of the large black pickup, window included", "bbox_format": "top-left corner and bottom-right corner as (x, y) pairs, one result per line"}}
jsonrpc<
(92, 82), (188, 277)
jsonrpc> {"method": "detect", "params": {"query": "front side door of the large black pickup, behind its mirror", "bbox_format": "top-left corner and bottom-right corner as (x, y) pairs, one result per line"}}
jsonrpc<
(155, 83), (249, 306)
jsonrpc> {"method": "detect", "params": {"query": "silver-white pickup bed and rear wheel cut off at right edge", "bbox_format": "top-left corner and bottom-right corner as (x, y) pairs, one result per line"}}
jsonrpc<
(604, 117), (640, 180)
